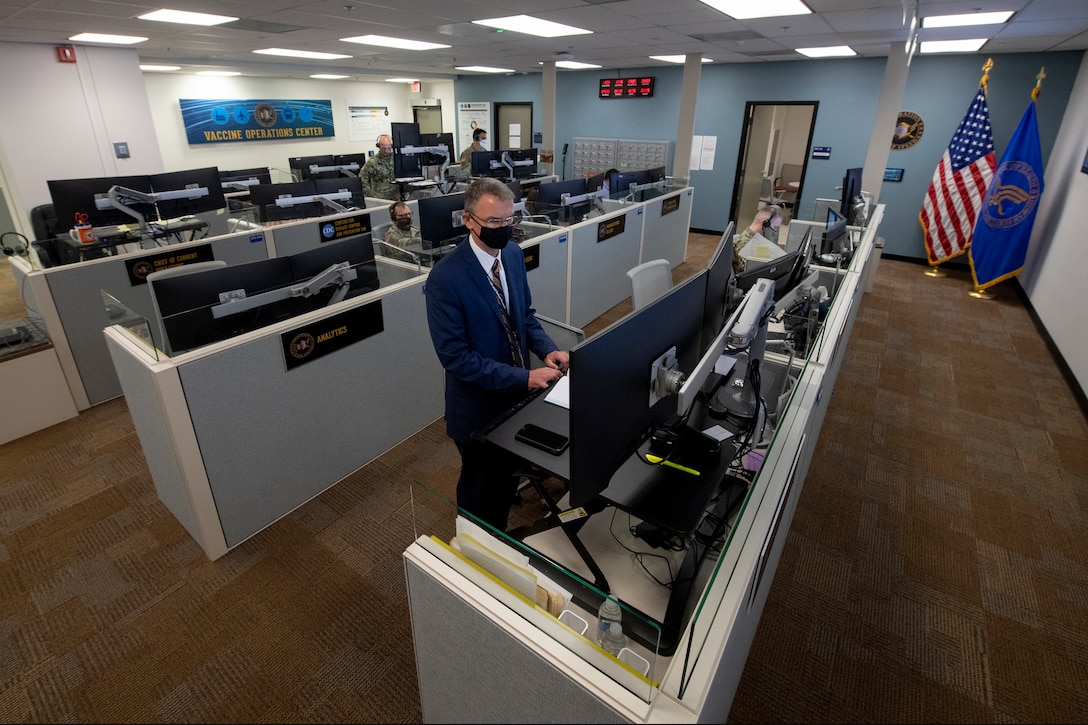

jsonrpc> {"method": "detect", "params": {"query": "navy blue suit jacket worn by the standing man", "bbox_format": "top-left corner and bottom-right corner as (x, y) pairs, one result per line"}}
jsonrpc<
(424, 237), (558, 442)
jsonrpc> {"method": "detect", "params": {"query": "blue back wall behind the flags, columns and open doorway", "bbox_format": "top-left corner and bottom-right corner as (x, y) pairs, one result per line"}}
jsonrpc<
(454, 51), (1083, 258)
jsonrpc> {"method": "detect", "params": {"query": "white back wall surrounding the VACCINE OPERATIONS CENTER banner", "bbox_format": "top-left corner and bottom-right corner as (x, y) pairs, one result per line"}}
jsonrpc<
(144, 73), (454, 181)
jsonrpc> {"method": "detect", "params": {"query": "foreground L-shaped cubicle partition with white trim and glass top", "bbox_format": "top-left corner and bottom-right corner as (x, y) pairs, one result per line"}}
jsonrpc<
(405, 205), (880, 723)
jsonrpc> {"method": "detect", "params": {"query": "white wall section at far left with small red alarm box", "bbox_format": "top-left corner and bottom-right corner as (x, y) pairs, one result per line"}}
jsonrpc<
(0, 42), (163, 228)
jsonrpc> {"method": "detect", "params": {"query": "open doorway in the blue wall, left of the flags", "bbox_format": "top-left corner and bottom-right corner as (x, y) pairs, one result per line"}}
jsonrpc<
(729, 101), (819, 229)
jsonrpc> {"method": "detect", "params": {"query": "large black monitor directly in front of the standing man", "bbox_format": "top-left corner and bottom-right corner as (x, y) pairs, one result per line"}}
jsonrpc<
(570, 270), (707, 506)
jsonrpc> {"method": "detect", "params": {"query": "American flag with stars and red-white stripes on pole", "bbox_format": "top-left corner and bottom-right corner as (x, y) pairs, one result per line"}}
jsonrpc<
(918, 84), (998, 266)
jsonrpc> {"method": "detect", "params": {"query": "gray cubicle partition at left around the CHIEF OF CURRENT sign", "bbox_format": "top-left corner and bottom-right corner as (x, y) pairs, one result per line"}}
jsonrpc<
(40, 230), (268, 405)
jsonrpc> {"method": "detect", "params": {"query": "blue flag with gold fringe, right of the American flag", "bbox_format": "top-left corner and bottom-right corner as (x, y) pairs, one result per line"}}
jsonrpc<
(968, 98), (1042, 290)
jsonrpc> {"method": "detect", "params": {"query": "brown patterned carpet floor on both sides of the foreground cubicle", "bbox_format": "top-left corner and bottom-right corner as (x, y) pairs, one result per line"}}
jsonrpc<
(0, 247), (1088, 723)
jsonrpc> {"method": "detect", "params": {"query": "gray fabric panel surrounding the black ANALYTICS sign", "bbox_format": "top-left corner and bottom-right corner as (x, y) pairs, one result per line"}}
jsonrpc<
(172, 279), (444, 546)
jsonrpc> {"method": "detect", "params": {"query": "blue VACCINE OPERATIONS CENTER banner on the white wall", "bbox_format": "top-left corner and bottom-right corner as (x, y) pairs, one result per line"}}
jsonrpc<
(178, 98), (335, 144)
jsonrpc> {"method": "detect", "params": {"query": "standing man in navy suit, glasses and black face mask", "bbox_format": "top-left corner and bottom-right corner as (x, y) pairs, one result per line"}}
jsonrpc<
(425, 179), (570, 531)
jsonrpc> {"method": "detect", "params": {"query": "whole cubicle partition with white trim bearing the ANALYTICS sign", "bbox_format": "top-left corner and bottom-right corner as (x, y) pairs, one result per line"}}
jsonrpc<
(106, 259), (443, 560)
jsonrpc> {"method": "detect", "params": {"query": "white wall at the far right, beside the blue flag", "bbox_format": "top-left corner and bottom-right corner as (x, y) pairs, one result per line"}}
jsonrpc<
(1016, 54), (1088, 393)
